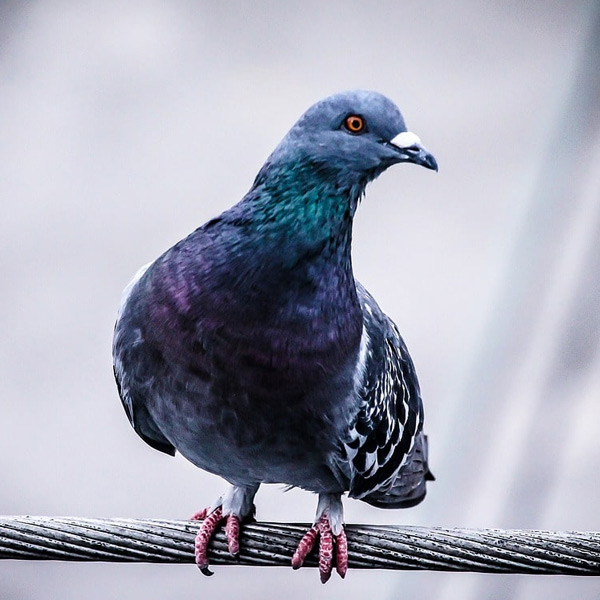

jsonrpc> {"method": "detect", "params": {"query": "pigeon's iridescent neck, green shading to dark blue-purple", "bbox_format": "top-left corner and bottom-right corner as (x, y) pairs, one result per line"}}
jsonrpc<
(226, 162), (362, 314)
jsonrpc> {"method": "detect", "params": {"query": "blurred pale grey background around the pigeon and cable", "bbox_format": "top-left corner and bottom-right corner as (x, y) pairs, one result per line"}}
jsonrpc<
(0, 0), (600, 600)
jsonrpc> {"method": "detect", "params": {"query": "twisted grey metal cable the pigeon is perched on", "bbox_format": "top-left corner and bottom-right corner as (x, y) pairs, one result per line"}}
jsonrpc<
(0, 516), (600, 575)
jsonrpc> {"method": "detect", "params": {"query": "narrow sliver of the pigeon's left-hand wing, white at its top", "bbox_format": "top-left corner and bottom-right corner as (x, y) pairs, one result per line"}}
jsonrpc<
(113, 265), (175, 456)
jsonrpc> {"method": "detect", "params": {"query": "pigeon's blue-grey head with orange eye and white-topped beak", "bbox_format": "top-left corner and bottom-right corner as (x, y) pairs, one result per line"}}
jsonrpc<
(273, 90), (437, 182)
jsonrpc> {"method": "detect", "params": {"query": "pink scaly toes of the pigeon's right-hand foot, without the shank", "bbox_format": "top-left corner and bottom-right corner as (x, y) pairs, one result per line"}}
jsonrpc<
(292, 515), (348, 583)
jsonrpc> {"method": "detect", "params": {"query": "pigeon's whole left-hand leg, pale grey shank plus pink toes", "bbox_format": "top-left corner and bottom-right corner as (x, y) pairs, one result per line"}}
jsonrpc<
(191, 485), (258, 575)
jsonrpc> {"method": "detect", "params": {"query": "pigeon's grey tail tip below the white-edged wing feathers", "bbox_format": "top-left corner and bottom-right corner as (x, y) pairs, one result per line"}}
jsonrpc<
(361, 433), (435, 508)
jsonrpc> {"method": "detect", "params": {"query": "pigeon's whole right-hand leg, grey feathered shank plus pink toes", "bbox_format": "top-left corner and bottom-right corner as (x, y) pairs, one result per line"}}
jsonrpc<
(292, 494), (348, 583)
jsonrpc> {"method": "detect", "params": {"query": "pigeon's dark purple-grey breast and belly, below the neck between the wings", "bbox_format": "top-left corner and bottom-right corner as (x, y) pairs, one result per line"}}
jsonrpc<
(117, 251), (360, 491)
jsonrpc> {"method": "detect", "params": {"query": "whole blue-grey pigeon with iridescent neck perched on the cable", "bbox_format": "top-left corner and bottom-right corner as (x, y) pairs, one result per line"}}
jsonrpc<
(113, 90), (437, 582)
